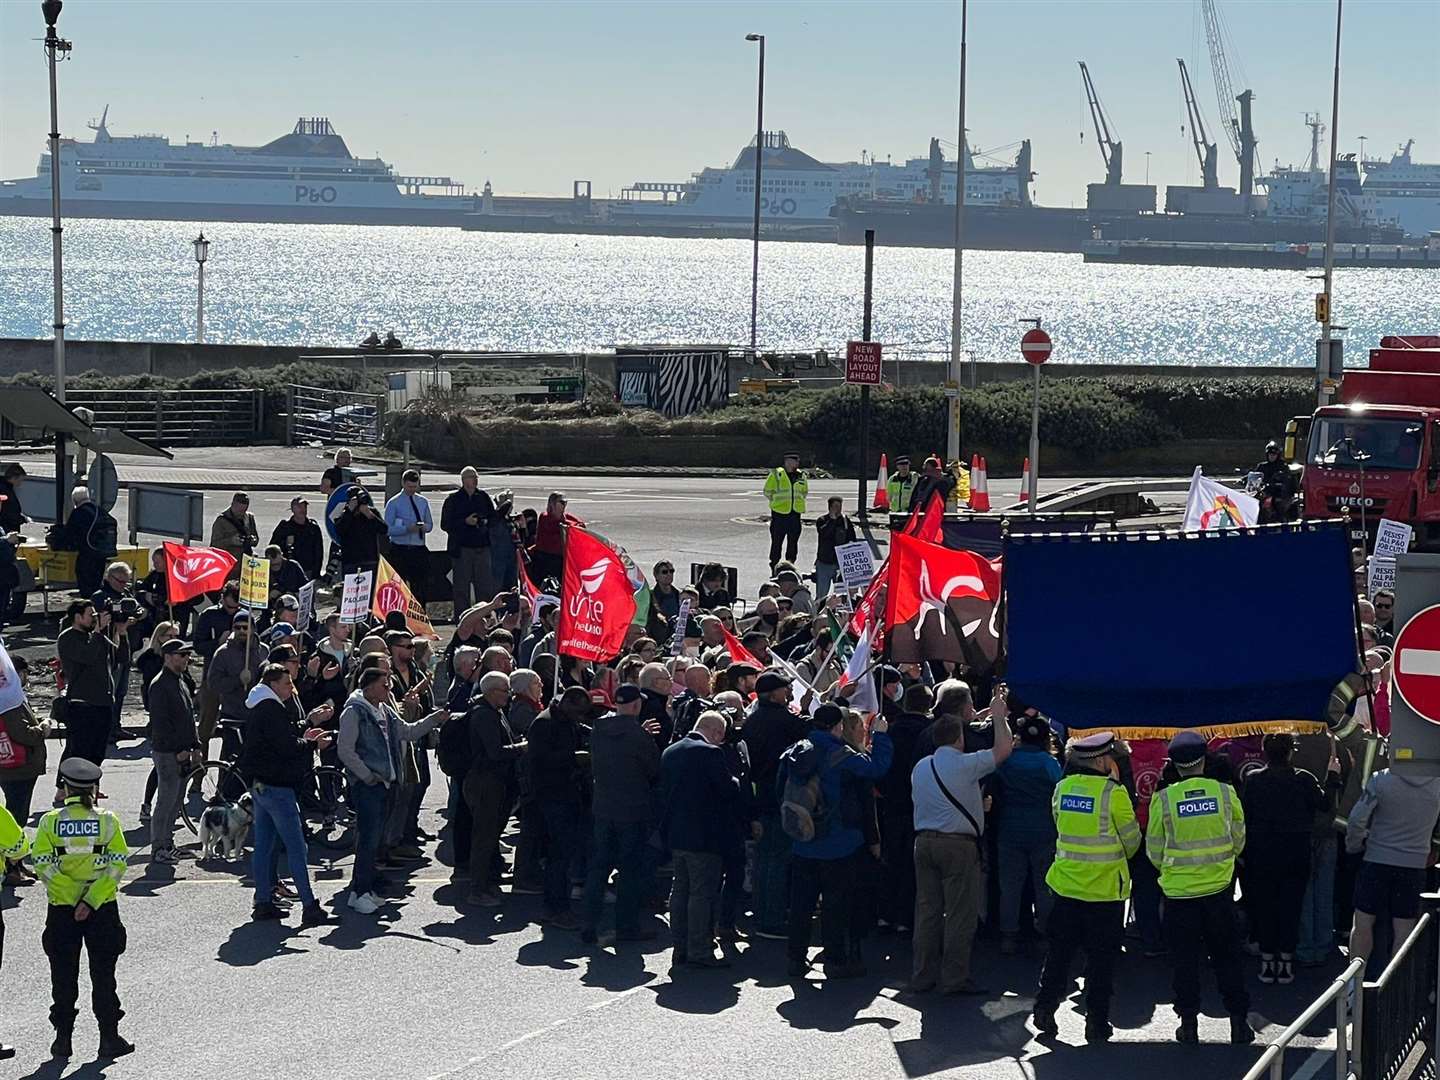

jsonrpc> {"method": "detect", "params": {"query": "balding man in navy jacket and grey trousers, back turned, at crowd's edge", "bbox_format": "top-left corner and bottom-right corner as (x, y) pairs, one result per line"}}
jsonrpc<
(660, 711), (740, 969)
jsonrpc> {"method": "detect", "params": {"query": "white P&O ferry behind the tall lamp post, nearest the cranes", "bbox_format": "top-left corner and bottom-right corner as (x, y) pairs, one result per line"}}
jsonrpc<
(608, 131), (1030, 228)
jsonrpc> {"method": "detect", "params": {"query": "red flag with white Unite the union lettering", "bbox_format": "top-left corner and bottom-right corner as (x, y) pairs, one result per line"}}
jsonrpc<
(556, 526), (635, 660)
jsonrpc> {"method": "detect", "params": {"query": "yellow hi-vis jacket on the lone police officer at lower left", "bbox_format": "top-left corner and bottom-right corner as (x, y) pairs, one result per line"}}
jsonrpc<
(35, 798), (130, 907)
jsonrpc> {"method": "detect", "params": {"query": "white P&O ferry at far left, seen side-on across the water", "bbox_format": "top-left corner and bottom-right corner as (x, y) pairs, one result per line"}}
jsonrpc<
(0, 108), (478, 225)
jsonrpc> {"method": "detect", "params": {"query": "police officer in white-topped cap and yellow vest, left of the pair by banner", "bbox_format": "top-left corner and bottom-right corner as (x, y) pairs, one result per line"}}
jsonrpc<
(1031, 732), (1140, 1043)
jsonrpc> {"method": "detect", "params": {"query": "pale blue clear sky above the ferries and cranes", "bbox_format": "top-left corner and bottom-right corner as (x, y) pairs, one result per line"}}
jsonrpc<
(0, 0), (1440, 206)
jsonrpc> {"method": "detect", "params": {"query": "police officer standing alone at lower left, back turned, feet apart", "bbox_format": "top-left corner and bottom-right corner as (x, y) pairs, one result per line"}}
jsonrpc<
(35, 757), (135, 1058)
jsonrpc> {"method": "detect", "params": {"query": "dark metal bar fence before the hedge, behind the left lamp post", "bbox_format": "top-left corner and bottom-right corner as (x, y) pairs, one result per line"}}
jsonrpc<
(65, 389), (265, 446)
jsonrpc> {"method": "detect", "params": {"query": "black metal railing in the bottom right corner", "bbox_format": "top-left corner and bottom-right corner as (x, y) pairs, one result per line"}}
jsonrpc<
(1355, 894), (1440, 1080)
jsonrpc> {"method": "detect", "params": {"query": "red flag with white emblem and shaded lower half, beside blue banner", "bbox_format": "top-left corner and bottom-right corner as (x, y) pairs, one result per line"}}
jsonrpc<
(886, 533), (999, 667)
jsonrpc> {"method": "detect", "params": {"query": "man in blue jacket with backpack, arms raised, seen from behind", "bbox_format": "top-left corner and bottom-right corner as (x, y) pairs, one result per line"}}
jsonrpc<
(776, 704), (894, 978)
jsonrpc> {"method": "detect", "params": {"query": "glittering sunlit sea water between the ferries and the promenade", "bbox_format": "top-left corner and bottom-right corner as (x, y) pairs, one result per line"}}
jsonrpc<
(0, 217), (1422, 366)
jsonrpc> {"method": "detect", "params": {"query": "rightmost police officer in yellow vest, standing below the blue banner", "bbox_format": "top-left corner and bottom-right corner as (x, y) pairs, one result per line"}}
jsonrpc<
(1145, 732), (1256, 1045)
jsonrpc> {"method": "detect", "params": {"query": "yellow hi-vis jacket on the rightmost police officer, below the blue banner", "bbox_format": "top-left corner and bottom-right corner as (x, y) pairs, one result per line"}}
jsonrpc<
(1145, 776), (1246, 900)
